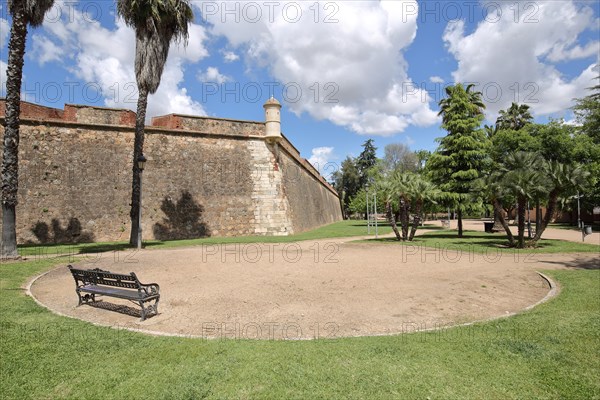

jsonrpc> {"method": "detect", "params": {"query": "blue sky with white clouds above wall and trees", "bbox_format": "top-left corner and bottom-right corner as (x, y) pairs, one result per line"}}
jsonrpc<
(0, 0), (600, 175)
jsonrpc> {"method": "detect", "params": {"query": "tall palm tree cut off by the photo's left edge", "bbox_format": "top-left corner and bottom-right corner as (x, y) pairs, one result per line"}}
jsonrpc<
(0, 0), (54, 258)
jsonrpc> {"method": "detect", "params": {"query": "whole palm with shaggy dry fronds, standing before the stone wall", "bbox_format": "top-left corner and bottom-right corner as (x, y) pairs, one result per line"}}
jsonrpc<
(117, 0), (194, 245)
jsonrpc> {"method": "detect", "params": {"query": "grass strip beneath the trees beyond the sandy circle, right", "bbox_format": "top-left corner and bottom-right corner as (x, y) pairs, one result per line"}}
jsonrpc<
(361, 230), (600, 253)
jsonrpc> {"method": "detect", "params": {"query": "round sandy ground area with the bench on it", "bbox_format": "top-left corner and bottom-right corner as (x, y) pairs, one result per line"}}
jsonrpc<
(31, 224), (598, 339)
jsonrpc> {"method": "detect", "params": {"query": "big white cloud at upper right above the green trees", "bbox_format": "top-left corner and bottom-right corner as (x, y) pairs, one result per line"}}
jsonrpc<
(443, 1), (600, 120)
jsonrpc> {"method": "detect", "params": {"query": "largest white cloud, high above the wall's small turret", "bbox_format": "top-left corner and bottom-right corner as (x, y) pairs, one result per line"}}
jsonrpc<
(195, 0), (437, 136)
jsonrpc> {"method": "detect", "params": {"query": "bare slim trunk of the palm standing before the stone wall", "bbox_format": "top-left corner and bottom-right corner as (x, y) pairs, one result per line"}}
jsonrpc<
(129, 89), (148, 246)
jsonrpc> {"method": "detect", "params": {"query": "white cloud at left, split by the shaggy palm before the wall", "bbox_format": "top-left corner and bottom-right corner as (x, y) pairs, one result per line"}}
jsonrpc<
(31, 2), (208, 118)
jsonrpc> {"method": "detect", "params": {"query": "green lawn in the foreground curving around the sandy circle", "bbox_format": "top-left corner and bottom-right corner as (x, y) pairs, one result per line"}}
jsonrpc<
(0, 259), (600, 399)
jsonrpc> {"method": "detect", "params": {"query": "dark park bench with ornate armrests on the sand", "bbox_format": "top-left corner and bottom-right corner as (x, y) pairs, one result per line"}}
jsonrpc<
(68, 265), (160, 321)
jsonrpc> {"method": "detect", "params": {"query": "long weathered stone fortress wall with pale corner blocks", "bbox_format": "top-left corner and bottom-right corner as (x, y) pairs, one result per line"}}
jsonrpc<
(0, 99), (342, 243)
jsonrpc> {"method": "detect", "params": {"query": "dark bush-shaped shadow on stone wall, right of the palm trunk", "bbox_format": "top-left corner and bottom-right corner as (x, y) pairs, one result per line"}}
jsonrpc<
(154, 191), (210, 240)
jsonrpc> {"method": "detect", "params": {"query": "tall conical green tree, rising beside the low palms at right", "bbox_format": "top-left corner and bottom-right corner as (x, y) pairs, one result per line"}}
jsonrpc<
(428, 83), (489, 237)
